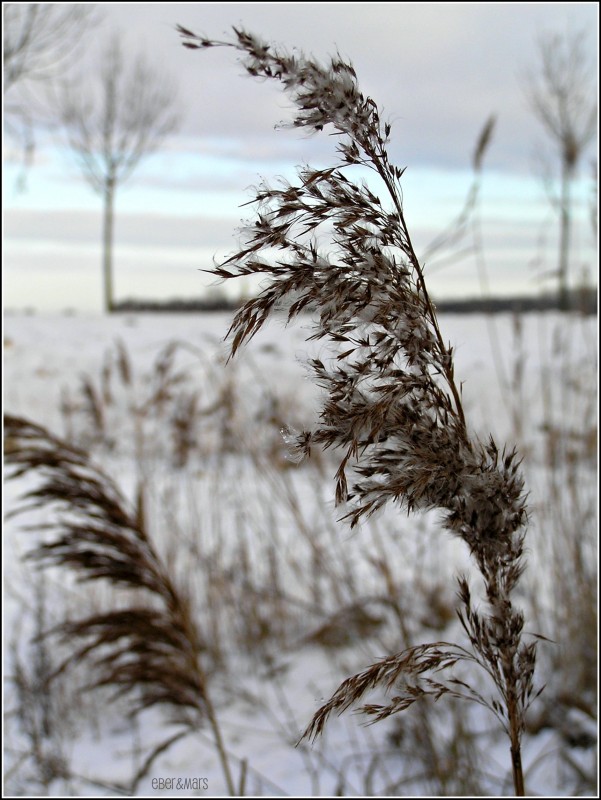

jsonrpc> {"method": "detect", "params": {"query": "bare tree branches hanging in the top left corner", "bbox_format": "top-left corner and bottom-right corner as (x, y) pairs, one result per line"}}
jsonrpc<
(2, 3), (98, 170)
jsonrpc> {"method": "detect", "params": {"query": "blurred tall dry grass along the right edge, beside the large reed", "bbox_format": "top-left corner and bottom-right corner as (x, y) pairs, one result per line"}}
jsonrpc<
(516, 315), (598, 794)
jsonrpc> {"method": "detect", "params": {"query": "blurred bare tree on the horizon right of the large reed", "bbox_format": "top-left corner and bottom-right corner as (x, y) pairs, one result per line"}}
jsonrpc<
(525, 32), (597, 310)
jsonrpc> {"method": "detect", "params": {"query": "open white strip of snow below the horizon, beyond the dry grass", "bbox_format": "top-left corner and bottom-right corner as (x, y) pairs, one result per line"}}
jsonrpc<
(4, 313), (597, 450)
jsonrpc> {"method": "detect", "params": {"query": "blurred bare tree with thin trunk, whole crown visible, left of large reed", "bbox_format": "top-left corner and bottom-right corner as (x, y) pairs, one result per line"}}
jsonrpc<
(59, 36), (179, 312)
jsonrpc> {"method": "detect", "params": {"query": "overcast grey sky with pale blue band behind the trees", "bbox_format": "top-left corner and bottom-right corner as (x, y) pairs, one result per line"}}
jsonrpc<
(3, 2), (598, 311)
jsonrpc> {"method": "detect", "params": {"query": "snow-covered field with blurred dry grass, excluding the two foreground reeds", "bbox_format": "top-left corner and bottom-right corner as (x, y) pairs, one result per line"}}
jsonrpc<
(4, 313), (597, 796)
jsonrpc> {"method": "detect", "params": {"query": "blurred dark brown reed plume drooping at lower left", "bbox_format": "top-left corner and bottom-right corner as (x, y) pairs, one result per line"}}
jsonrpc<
(4, 415), (235, 794)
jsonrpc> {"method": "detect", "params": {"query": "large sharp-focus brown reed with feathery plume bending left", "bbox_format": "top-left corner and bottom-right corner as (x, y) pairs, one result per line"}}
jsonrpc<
(178, 26), (536, 795)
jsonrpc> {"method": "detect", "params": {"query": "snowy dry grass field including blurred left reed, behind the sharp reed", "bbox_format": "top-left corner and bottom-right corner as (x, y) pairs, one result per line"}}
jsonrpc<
(4, 313), (598, 796)
